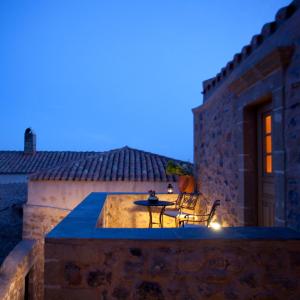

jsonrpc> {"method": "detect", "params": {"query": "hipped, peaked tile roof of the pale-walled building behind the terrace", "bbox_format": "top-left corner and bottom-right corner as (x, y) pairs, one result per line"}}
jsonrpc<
(30, 147), (186, 182)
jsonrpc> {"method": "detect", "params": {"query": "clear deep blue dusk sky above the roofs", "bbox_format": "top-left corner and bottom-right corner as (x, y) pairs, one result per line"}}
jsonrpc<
(0, 0), (291, 161)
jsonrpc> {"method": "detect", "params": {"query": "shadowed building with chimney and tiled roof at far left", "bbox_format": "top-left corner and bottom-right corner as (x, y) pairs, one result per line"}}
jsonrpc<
(0, 128), (95, 263)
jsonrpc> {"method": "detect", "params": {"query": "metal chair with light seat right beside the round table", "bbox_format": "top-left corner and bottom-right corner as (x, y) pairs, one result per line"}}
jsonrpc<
(163, 193), (200, 227)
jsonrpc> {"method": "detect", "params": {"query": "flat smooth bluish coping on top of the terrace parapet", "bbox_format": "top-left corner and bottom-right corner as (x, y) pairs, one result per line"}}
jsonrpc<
(45, 193), (300, 243)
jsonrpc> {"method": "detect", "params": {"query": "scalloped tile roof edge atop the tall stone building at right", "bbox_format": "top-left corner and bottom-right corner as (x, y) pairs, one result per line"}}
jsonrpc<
(202, 0), (300, 95)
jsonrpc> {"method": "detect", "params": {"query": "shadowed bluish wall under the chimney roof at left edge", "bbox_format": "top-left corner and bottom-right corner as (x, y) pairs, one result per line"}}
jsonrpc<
(0, 183), (27, 264)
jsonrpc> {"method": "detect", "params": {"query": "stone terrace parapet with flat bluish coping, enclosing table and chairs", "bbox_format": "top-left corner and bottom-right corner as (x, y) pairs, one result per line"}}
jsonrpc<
(45, 193), (300, 299)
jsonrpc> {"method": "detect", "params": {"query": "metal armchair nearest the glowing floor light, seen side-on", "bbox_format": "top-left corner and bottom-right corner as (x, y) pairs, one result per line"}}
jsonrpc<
(179, 200), (220, 227)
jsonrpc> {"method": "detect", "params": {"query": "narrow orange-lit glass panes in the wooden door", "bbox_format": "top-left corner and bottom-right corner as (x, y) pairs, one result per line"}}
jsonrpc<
(263, 113), (273, 174)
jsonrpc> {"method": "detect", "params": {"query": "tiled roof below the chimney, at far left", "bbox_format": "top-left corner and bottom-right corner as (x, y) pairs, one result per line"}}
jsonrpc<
(0, 151), (100, 174)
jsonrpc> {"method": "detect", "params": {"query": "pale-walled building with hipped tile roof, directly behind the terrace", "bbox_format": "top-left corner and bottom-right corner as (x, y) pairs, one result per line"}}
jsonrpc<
(23, 146), (183, 244)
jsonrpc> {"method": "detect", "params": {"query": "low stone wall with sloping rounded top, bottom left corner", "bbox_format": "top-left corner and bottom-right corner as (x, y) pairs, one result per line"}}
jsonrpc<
(0, 240), (41, 300)
